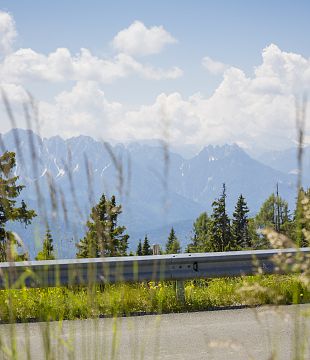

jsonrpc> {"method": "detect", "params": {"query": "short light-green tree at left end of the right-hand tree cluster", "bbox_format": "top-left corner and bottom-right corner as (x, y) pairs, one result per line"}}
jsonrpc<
(186, 212), (211, 252)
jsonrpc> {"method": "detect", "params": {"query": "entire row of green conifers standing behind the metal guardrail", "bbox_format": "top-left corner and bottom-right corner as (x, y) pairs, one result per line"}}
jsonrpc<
(0, 152), (310, 261)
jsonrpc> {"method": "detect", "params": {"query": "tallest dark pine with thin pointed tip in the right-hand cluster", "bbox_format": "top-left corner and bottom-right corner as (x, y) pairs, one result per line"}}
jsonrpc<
(209, 184), (233, 251)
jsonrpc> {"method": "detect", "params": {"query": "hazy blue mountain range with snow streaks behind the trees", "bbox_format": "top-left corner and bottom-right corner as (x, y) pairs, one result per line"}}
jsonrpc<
(0, 129), (302, 257)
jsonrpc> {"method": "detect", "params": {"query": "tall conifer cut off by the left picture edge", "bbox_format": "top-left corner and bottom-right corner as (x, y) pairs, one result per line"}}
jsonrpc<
(0, 151), (36, 261)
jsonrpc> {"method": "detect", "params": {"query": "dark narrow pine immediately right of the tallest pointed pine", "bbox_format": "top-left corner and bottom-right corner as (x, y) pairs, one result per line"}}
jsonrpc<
(231, 195), (251, 250)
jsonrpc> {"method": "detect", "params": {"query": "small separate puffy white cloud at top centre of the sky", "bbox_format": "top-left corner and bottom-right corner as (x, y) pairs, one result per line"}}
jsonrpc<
(112, 21), (177, 56)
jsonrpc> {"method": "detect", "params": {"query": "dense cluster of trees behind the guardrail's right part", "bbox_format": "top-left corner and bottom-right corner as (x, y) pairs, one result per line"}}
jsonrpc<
(186, 184), (300, 252)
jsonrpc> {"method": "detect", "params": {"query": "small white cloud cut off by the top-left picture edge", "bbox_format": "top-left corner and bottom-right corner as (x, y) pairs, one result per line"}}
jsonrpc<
(0, 11), (17, 56)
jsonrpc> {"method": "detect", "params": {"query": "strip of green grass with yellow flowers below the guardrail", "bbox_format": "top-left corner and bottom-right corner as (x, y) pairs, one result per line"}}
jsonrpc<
(0, 275), (310, 322)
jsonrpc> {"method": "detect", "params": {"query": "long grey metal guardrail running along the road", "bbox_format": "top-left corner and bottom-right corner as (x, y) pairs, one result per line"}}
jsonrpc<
(0, 248), (310, 289)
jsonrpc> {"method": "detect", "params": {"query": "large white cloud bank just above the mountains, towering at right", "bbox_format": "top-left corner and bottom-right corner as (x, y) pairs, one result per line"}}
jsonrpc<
(30, 45), (310, 153)
